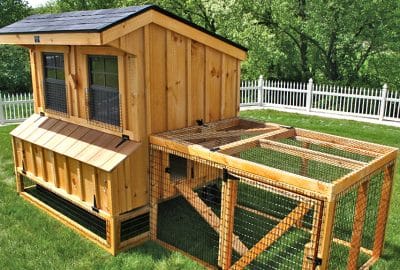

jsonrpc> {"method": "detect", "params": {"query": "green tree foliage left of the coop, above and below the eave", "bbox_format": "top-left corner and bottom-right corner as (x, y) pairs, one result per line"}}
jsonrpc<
(0, 0), (32, 92)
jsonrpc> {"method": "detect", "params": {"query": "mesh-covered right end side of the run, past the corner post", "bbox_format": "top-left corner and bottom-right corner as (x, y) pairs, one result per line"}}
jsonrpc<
(329, 165), (394, 269)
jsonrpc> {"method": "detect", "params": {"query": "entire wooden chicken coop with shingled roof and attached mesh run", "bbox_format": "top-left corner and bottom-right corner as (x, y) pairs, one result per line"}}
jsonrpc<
(0, 5), (397, 269)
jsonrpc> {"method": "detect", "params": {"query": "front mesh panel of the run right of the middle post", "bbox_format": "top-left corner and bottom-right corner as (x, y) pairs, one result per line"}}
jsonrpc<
(233, 178), (322, 269)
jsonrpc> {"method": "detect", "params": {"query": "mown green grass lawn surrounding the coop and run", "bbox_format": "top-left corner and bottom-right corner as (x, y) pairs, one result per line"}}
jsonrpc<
(0, 110), (400, 269)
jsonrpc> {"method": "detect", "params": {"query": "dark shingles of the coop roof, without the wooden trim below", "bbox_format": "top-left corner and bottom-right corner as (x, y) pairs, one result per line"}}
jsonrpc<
(0, 5), (247, 51)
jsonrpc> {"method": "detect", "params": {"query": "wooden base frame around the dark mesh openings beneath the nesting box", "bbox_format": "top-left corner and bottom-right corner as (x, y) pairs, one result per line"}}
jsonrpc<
(16, 170), (149, 256)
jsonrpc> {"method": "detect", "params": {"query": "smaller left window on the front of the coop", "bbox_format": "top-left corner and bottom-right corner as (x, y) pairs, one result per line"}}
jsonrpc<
(43, 53), (67, 113)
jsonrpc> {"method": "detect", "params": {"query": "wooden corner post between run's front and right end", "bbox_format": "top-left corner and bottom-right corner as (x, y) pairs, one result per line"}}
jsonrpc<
(319, 200), (336, 270)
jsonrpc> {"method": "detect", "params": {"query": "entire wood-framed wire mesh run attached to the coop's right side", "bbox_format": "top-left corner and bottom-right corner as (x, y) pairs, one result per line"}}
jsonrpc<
(151, 118), (396, 269)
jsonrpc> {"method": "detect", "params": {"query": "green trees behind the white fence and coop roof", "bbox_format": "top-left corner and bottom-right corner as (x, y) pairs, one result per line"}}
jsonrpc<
(0, 0), (400, 91)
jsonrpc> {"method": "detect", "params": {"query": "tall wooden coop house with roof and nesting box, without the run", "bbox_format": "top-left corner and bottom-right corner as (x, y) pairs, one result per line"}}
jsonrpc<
(0, 6), (246, 254)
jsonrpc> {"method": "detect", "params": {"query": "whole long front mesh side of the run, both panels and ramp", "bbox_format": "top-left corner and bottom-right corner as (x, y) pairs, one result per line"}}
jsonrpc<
(150, 145), (323, 269)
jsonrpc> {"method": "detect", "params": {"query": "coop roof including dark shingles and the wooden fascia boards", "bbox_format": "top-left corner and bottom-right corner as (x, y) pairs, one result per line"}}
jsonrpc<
(0, 5), (247, 60)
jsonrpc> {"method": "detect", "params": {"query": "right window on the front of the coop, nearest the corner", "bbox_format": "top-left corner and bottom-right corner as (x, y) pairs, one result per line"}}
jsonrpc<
(88, 55), (121, 126)
